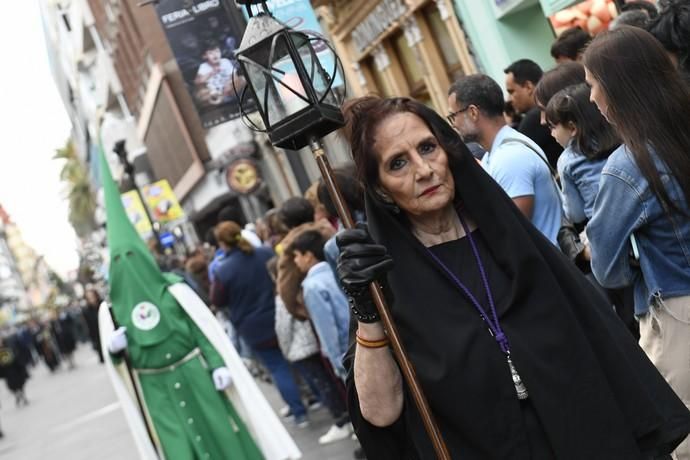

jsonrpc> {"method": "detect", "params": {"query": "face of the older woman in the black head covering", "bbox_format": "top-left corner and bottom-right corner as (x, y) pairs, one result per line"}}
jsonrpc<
(374, 112), (455, 216)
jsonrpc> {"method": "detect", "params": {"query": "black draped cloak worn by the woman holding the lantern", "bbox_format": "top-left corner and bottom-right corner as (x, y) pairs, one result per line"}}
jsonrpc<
(345, 116), (690, 460)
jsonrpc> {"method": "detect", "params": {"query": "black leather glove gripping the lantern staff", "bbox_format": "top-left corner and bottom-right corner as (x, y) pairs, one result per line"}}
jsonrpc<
(335, 225), (393, 323)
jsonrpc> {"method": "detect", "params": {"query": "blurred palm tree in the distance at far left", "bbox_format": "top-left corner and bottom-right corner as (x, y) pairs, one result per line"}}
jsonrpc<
(53, 140), (96, 238)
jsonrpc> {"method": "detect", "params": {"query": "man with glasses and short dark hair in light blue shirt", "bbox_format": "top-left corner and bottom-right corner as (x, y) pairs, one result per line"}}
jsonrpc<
(448, 74), (562, 245)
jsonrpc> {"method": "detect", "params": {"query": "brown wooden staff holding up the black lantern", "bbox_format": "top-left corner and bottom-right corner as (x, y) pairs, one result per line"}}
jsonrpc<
(309, 139), (451, 460)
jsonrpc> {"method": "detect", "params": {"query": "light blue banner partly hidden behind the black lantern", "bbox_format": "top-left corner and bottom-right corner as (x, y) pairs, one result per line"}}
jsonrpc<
(242, 0), (343, 88)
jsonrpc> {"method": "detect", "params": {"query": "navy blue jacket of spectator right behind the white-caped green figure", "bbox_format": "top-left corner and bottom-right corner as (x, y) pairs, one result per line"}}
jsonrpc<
(211, 247), (276, 347)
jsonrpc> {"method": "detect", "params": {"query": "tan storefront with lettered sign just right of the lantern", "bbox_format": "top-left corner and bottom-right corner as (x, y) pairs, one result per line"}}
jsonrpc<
(312, 0), (477, 113)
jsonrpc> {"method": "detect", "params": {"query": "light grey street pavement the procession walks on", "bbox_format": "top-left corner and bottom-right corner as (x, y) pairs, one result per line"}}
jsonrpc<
(0, 345), (356, 460)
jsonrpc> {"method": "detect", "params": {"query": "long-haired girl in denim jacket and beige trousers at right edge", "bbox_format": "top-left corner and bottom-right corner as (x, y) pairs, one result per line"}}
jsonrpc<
(584, 27), (690, 460)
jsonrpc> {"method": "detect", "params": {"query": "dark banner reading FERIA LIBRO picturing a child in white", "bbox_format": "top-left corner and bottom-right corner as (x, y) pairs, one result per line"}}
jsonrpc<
(156, 0), (255, 128)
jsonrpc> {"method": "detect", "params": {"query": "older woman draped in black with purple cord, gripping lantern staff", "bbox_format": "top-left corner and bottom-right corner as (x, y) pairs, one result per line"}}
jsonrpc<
(338, 97), (690, 460)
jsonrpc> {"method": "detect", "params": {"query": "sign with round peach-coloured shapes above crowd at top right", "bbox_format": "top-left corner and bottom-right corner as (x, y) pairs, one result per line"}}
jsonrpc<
(542, 0), (618, 36)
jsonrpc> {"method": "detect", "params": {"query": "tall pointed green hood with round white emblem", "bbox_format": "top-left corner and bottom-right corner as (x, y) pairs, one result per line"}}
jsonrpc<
(99, 146), (179, 345)
